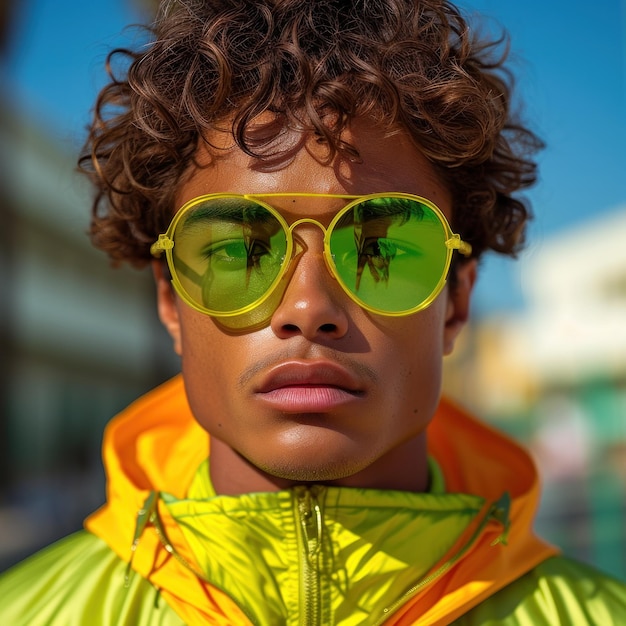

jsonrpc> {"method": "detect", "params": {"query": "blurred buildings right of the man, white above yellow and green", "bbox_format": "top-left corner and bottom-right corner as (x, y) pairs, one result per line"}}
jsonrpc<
(447, 206), (626, 579)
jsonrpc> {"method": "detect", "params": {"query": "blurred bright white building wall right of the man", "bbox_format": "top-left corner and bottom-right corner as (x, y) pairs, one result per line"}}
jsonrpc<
(523, 205), (626, 382)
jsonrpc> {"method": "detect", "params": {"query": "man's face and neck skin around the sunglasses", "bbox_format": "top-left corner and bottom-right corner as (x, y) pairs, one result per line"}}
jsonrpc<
(157, 124), (475, 491)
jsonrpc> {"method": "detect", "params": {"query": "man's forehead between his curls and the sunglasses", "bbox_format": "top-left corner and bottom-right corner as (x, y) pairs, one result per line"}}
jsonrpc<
(177, 118), (451, 215)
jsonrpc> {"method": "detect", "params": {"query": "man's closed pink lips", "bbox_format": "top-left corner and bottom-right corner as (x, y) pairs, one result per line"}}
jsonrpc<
(256, 361), (363, 413)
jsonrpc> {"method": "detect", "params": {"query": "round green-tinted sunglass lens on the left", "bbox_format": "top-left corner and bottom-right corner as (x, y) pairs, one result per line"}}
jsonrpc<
(172, 197), (287, 314)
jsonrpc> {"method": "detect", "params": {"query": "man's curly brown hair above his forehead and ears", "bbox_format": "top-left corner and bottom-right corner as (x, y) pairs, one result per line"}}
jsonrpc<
(79, 0), (541, 266)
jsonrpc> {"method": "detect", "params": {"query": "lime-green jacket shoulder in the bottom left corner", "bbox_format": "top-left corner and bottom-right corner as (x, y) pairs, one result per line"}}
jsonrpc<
(0, 531), (182, 626)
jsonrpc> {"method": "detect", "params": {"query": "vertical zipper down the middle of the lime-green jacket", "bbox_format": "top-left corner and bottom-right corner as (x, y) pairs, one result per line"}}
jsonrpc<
(296, 487), (322, 626)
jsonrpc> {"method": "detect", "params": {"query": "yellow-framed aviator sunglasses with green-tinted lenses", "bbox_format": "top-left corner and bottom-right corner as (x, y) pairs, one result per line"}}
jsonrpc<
(151, 193), (472, 318)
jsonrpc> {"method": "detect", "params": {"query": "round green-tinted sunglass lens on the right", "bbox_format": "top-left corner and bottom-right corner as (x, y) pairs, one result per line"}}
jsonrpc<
(329, 197), (450, 313)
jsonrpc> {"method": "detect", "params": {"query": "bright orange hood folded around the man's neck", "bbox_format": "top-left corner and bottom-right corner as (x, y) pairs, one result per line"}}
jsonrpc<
(87, 377), (555, 624)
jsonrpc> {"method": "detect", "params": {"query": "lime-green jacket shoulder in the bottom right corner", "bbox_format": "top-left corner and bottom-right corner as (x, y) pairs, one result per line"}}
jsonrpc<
(455, 557), (626, 626)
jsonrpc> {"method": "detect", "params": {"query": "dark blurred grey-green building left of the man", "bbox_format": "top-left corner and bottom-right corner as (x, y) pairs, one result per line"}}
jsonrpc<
(0, 102), (176, 568)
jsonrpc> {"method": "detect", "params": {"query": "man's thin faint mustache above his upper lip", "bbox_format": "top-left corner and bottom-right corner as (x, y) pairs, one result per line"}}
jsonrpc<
(237, 347), (378, 389)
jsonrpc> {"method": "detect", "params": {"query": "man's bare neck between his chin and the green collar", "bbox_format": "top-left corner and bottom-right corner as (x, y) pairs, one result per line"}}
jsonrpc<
(209, 433), (429, 496)
